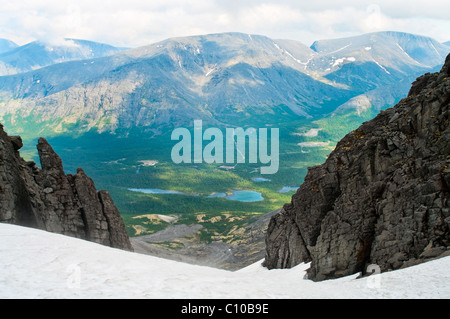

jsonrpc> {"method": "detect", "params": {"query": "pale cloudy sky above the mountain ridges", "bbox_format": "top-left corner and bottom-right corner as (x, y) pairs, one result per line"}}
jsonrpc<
(0, 0), (450, 47)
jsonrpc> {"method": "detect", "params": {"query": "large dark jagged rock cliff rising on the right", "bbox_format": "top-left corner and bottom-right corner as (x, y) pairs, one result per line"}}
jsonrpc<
(265, 56), (450, 280)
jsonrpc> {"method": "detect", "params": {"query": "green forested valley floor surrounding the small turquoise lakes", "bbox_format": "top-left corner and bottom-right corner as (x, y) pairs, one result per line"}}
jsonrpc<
(11, 106), (386, 242)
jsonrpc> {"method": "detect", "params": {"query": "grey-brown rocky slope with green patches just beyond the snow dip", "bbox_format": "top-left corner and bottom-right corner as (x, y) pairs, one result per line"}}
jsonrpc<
(131, 210), (279, 271)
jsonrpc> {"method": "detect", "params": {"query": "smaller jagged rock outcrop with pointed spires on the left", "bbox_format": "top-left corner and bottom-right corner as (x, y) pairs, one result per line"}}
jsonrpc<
(0, 124), (132, 250)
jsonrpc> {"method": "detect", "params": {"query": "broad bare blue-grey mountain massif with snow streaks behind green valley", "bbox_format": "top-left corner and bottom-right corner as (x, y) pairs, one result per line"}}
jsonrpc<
(0, 32), (449, 138)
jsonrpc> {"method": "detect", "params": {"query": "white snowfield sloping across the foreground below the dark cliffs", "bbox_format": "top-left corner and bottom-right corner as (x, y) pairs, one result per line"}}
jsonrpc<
(0, 224), (450, 299)
